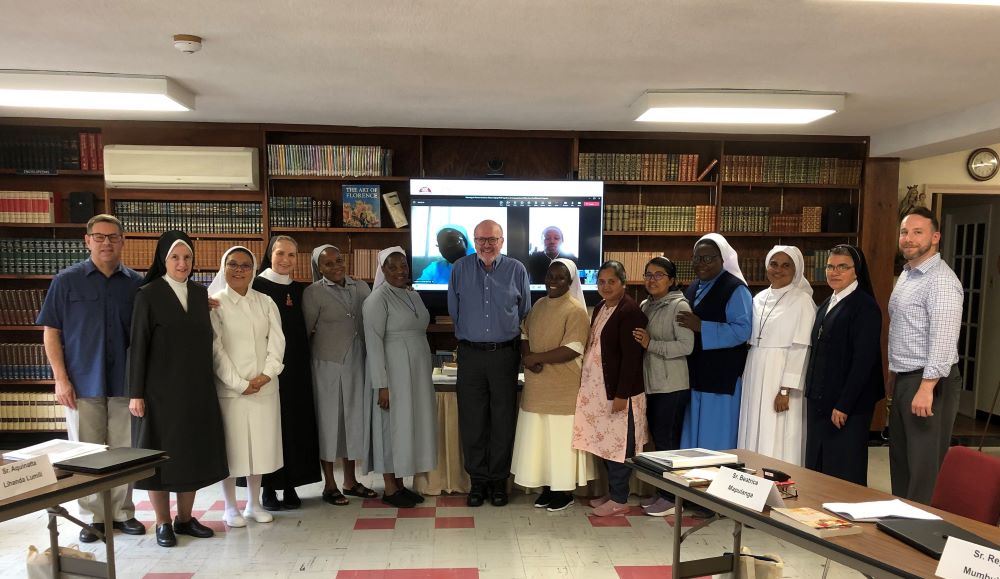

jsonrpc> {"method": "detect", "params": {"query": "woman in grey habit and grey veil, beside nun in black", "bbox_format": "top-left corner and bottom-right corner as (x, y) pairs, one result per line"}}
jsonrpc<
(302, 245), (378, 506)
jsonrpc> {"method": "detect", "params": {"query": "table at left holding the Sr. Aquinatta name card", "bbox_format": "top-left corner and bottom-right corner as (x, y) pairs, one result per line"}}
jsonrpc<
(0, 457), (168, 579)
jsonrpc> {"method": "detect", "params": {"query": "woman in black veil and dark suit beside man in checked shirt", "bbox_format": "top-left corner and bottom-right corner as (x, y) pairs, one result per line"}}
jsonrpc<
(805, 245), (885, 485)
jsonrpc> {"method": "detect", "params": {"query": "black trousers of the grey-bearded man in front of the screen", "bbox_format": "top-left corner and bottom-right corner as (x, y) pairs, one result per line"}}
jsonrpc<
(456, 343), (521, 485)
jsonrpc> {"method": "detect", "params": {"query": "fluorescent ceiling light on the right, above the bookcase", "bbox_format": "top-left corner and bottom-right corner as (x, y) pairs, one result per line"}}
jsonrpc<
(631, 90), (844, 125)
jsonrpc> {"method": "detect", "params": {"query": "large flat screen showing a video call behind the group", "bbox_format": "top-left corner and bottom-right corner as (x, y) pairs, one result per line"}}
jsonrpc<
(410, 179), (604, 291)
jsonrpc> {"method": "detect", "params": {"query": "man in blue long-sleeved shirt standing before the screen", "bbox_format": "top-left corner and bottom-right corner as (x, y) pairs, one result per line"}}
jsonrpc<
(448, 220), (531, 507)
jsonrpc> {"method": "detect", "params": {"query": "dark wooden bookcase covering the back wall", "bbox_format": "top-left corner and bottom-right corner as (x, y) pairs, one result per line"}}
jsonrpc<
(0, 119), (897, 441)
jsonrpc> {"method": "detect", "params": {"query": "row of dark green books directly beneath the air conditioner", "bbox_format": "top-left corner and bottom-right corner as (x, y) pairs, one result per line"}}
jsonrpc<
(113, 201), (261, 234)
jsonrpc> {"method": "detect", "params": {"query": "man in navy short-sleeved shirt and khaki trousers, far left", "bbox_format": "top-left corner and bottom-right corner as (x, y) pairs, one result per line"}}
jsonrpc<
(36, 214), (146, 543)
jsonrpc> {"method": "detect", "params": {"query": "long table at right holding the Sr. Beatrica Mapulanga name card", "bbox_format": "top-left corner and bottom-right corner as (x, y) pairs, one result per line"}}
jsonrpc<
(629, 450), (1000, 579)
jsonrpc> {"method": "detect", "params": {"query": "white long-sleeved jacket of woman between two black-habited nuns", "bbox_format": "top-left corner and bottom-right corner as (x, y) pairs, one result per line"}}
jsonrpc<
(211, 285), (285, 398)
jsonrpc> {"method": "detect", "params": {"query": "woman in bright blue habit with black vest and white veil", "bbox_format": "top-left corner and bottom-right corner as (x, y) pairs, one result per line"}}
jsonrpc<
(677, 233), (753, 450)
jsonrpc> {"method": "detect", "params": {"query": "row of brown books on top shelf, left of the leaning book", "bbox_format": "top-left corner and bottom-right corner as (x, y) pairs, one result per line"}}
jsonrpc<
(578, 153), (699, 181)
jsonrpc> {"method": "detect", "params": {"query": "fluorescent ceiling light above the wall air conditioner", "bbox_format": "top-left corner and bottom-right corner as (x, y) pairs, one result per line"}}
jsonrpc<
(0, 70), (194, 111)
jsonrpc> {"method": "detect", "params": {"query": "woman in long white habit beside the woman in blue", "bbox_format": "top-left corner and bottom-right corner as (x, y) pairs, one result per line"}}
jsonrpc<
(737, 245), (816, 465)
